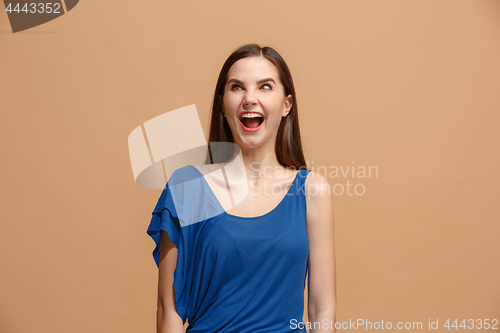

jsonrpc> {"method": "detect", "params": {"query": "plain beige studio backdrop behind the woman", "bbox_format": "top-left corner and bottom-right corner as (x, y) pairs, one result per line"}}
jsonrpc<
(0, 0), (500, 333)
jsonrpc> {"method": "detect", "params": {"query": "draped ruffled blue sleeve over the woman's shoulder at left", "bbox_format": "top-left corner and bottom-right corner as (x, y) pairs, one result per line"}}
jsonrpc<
(147, 165), (224, 323)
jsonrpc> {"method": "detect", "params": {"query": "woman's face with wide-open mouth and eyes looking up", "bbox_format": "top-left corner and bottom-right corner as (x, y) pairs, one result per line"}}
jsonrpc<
(222, 56), (292, 151)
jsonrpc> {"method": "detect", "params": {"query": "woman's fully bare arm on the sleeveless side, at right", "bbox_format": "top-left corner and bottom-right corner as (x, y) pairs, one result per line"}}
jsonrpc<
(305, 171), (337, 333)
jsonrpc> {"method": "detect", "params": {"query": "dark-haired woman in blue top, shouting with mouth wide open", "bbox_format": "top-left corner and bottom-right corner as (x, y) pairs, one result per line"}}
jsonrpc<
(148, 44), (336, 333)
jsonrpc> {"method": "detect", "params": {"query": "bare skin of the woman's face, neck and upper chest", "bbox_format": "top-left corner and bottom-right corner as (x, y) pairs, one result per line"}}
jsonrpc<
(222, 57), (296, 217)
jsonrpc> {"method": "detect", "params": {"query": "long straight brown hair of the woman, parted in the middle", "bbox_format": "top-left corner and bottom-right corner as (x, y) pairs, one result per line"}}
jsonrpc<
(206, 44), (307, 169)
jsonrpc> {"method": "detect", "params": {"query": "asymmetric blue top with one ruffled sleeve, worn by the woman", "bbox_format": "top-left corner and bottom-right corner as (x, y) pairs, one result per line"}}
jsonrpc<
(147, 165), (310, 333)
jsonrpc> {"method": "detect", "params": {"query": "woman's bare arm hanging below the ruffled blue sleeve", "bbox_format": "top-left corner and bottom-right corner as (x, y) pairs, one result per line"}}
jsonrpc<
(156, 230), (184, 333)
